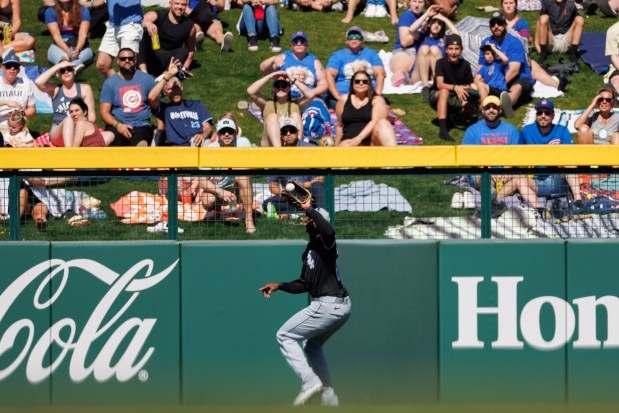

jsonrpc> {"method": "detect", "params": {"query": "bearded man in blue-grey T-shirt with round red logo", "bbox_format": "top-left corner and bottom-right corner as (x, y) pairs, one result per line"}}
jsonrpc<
(99, 48), (155, 146)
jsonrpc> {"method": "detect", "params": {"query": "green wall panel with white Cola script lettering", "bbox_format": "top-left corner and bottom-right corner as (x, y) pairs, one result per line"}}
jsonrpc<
(0, 242), (180, 405)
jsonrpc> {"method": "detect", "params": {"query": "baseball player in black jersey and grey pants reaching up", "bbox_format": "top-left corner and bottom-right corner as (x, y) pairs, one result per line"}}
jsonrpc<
(260, 198), (351, 406)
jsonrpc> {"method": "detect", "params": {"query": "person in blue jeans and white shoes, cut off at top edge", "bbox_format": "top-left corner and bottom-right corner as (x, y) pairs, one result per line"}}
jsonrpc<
(239, 0), (282, 53)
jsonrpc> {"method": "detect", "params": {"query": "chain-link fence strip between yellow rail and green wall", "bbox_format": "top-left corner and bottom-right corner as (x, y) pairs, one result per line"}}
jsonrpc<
(0, 168), (619, 241)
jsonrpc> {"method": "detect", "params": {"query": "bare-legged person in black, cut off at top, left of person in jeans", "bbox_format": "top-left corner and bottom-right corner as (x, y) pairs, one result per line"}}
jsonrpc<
(185, 0), (234, 52)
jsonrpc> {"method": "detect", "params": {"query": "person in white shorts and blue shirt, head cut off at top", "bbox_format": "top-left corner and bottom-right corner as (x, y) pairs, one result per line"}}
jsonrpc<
(97, 0), (144, 78)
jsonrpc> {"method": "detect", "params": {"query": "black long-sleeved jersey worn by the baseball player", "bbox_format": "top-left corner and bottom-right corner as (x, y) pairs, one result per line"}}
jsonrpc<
(279, 207), (348, 298)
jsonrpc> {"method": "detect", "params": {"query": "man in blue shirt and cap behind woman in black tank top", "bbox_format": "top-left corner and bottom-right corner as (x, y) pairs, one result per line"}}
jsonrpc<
(327, 26), (386, 108)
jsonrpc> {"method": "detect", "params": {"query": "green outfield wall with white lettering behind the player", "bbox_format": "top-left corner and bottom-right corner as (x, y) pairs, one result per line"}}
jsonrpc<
(0, 240), (619, 405)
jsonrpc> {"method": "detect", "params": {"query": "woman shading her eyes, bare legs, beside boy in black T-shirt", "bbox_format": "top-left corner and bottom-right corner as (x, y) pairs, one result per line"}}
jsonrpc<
(413, 13), (460, 96)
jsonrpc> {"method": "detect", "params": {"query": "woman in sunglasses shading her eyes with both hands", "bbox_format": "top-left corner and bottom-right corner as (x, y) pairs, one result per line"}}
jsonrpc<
(247, 71), (314, 147)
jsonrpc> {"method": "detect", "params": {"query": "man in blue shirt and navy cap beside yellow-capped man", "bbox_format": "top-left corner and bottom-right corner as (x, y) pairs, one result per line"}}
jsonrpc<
(517, 99), (583, 214)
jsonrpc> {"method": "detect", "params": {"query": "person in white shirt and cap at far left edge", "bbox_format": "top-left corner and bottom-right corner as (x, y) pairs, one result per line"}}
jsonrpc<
(0, 50), (36, 140)
